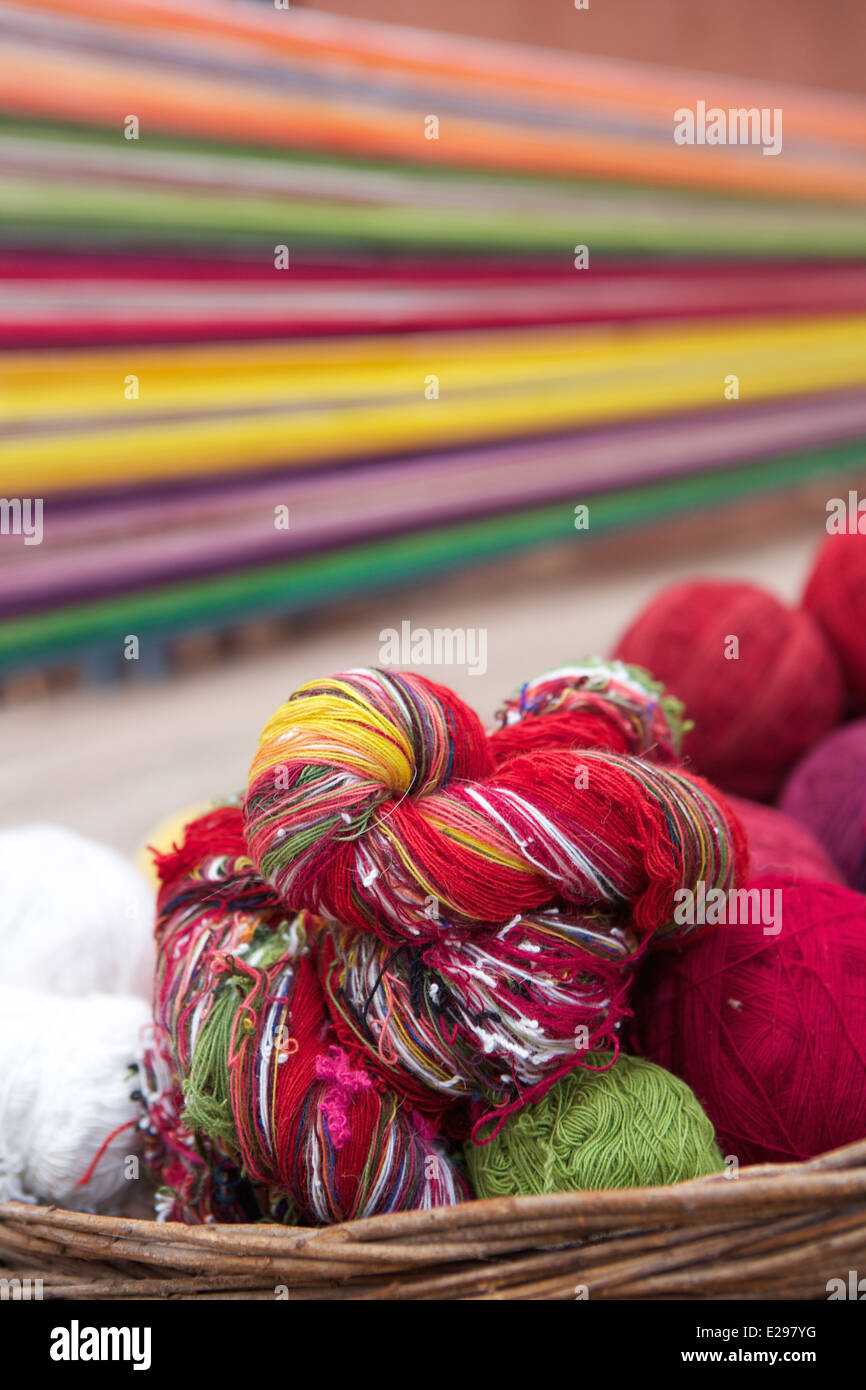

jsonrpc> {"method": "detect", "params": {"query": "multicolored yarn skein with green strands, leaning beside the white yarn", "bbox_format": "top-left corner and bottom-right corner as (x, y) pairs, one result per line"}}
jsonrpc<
(145, 808), (466, 1222)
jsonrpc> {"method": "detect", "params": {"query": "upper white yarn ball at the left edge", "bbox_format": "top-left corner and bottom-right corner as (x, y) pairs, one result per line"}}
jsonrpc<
(0, 824), (156, 999)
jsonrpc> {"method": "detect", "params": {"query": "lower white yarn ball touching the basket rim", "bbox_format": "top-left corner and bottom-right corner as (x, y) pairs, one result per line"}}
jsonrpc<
(0, 986), (150, 1211)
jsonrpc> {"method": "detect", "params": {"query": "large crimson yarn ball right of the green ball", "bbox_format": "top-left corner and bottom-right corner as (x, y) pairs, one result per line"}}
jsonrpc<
(632, 874), (866, 1163)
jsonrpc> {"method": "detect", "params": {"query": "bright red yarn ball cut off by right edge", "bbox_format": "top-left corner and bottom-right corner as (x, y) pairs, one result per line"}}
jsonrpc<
(803, 531), (866, 712)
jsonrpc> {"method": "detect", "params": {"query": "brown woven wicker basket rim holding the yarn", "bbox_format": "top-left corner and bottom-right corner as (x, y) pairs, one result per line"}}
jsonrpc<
(0, 1143), (866, 1300)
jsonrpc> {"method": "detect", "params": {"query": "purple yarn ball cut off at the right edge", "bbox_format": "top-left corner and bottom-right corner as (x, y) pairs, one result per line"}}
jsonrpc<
(778, 719), (866, 892)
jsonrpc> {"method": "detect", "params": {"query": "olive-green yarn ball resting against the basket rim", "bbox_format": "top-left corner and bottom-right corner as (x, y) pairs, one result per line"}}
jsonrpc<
(466, 1052), (724, 1197)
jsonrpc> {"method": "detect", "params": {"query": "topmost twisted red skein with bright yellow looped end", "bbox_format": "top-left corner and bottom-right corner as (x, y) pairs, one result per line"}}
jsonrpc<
(245, 670), (746, 944)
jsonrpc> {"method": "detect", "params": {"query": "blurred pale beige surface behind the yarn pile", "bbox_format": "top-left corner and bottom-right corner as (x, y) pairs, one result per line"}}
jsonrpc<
(0, 484), (831, 852)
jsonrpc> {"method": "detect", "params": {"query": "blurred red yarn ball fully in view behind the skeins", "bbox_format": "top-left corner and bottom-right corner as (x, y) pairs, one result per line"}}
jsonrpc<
(616, 580), (844, 801)
